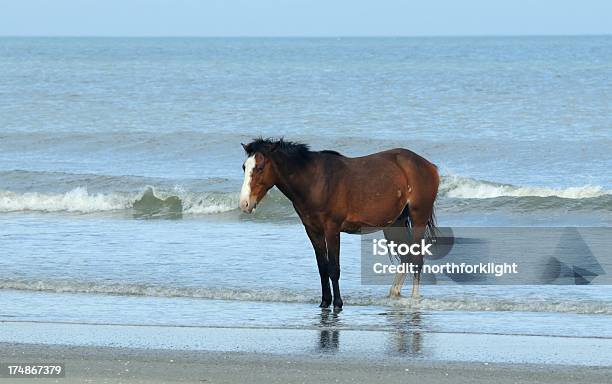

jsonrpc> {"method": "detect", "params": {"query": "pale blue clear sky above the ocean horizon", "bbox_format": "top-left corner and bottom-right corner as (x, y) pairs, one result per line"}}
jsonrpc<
(0, 0), (612, 36)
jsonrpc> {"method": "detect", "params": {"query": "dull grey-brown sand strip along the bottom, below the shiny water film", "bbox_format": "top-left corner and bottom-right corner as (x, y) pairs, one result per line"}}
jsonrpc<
(0, 344), (612, 384)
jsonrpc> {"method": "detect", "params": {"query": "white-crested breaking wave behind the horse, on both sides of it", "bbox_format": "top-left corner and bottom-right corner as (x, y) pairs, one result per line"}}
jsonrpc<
(0, 175), (612, 216)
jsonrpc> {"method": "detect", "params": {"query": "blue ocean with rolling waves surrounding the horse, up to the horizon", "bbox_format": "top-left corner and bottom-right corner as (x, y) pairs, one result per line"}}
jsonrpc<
(0, 36), (612, 354)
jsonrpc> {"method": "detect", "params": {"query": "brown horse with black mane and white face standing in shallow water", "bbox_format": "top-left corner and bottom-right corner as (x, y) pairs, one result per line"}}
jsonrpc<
(240, 138), (440, 309)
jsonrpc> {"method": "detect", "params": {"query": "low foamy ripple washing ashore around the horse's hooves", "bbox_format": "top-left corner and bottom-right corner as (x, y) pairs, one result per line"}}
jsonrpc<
(0, 280), (612, 315)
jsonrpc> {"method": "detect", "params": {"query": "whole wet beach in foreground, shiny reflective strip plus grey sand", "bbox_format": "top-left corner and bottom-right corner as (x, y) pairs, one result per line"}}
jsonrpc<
(0, 306), (612, 384)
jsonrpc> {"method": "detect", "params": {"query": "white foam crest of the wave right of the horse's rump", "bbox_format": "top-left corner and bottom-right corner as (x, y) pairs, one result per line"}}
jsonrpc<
(440, 175), (612, 199)
